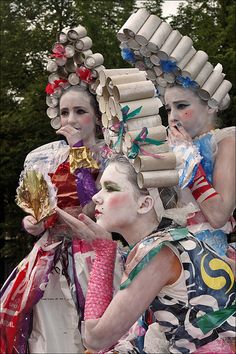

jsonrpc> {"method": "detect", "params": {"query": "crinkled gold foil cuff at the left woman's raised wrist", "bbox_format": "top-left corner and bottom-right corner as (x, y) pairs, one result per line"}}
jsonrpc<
(69, 146), (99, 173)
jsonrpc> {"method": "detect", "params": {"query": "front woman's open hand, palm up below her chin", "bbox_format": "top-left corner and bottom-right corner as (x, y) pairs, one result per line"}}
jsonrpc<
(56, 207), (112, 242)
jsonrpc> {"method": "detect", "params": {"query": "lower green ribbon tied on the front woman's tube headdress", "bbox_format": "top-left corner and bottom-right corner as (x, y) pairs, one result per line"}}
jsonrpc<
(128, 127), (164, 159)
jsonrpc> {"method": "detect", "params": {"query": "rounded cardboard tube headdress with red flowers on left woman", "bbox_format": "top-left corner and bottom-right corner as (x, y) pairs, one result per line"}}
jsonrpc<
(46, 25), (104, 129)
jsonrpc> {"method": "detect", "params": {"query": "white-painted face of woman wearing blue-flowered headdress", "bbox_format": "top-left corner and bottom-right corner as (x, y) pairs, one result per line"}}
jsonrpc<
(165, 86), (212, 138)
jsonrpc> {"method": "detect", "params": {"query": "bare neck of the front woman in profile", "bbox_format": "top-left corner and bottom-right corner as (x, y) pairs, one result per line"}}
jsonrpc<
(118, 212), (159, 245)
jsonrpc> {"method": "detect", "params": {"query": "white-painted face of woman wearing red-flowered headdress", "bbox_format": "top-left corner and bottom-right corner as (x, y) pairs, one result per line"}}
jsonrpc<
(60, 90), (96, 141)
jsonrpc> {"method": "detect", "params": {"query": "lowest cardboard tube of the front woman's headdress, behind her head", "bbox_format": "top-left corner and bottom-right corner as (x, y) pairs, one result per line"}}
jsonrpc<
(137, 170), (179, 188)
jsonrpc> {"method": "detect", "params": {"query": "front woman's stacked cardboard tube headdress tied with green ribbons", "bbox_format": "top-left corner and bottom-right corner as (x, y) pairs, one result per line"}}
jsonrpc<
(98, 68), (181, 188)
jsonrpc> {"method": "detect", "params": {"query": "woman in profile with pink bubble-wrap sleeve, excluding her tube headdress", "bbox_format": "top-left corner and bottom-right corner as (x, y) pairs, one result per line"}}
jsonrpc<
(57, 155), (236, 354)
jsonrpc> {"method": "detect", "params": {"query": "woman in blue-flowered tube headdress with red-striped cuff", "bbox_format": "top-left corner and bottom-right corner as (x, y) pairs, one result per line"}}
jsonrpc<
(117, 8), (236, 255)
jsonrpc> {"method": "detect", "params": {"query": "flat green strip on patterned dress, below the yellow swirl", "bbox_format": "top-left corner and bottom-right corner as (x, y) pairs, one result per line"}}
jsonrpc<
(197, 304), (236, 334)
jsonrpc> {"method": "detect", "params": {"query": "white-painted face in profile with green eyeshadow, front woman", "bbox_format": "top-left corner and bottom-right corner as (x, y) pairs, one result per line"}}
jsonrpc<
(93, 163), (138, 234)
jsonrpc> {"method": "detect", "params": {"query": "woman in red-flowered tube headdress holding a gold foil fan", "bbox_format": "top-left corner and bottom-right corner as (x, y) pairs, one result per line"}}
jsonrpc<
(1, 26), (124, 354)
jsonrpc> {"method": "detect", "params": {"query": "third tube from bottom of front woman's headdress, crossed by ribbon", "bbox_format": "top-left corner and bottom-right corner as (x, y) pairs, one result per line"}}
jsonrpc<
(125, 125), (167, 148)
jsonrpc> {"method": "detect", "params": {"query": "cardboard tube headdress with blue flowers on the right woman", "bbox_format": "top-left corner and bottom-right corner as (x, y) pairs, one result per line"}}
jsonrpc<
(117, 8), (232, 110)
